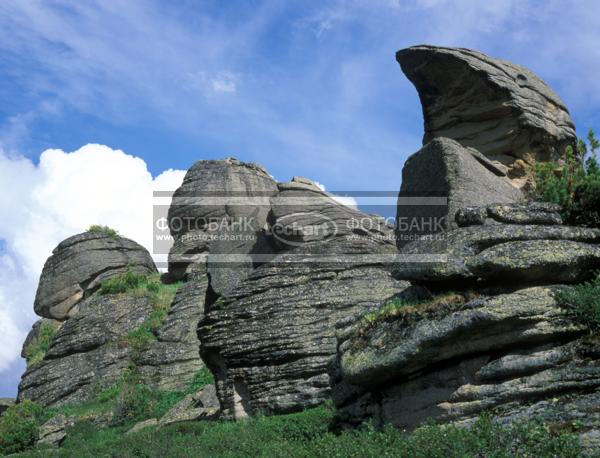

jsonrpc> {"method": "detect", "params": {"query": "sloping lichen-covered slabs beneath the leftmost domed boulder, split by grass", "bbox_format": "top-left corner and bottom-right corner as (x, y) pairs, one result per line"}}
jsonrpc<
(18, 264), (208, 406)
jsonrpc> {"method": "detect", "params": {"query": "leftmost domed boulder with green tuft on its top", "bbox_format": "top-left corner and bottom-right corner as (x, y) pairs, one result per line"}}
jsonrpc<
(34, 232), (156, 321)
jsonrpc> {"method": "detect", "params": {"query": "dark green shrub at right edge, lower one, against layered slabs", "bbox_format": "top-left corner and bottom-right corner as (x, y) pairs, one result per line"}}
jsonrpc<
(557, 273), (600, 333)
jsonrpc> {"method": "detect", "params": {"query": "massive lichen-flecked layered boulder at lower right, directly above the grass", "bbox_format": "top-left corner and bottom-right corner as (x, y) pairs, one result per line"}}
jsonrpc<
(332, 287), (600, 448)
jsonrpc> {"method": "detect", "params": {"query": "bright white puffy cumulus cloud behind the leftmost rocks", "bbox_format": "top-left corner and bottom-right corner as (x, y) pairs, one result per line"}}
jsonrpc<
(0, 144), (185, 378)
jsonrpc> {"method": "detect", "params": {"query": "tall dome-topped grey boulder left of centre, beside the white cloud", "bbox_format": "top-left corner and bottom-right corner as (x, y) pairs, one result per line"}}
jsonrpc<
(168, 158), (277, 294)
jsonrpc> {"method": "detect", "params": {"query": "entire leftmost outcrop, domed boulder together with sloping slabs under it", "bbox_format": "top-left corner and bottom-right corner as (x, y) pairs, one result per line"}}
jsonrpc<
(18, 233), (208, 406)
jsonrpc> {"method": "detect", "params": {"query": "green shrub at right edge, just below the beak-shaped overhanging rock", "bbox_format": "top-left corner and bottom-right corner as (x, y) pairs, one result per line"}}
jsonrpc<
(534, 129), (600, 227)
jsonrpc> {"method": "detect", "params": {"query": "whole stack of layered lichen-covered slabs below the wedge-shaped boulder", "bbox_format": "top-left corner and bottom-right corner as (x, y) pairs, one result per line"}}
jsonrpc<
(331, 204), (600, 446)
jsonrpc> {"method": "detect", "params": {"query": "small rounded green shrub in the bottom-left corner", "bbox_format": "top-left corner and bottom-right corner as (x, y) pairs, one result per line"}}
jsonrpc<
(0, 401), (45, 455)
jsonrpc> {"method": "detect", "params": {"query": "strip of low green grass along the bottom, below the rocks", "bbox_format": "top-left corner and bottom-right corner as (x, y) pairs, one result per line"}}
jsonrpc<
(15, 406), (581, 458)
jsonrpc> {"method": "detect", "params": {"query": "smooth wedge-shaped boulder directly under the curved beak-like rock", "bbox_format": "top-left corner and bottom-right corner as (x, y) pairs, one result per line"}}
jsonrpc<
(396, 138), (524, 246)
